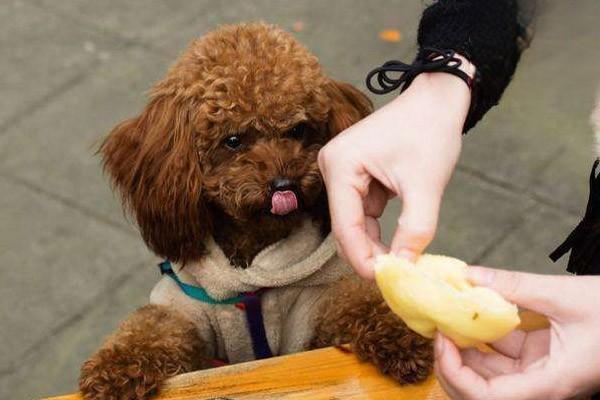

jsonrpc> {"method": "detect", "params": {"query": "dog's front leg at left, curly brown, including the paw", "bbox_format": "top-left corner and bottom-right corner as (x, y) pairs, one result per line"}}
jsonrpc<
(79, 305), (206, 400)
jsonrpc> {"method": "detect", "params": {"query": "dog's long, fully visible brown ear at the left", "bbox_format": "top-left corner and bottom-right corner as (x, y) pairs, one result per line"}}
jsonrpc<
(100, 96), (211, 263)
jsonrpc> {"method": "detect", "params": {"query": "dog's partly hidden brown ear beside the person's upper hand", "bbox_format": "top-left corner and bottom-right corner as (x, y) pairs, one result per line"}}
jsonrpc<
(325, 80), (373, 137)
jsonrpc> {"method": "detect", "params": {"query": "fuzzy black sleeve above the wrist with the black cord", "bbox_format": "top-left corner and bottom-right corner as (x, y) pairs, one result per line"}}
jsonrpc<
(417, 0), (525, 132)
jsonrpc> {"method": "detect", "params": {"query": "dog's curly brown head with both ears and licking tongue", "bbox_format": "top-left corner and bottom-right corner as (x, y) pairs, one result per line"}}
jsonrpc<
(101, 23), (372, 263)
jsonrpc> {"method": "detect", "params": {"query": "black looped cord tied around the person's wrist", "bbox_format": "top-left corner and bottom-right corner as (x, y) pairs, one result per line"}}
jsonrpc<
(366, 47), (473, 94)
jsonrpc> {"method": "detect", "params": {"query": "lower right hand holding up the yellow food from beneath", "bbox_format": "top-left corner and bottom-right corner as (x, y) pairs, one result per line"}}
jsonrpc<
(435, 267), (600, 400)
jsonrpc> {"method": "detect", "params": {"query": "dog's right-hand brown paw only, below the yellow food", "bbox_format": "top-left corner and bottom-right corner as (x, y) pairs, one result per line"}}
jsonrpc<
(352, 304), (434, 384)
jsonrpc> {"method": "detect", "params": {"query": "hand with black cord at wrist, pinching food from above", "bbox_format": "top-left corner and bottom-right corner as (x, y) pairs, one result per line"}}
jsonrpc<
(319, 73), (471, 279)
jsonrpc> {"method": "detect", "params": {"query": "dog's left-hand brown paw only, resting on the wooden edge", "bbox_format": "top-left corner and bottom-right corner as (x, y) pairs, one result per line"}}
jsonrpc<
(79, 346), (180, 400)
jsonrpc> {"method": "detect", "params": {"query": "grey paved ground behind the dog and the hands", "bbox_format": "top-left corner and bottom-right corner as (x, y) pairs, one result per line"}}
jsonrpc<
(0, 0), (600, 399)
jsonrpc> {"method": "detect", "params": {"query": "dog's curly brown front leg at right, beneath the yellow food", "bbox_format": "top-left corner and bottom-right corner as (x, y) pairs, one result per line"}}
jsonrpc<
(312, 279), (433, 384)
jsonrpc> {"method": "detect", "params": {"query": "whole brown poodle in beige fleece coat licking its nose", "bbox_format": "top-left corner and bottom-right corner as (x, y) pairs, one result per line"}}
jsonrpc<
(80, 23), (433, 399)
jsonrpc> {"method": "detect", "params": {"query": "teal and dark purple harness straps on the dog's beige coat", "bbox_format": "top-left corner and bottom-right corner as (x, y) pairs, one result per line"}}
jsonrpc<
(158, 260), (273, 360)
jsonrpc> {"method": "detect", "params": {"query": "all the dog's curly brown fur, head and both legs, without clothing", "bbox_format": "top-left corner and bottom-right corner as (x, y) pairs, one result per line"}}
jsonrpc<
(80, 23), (432, 399)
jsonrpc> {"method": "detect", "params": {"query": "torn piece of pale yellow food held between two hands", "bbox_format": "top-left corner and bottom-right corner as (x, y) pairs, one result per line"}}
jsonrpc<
(375, 254), (520, 347)
